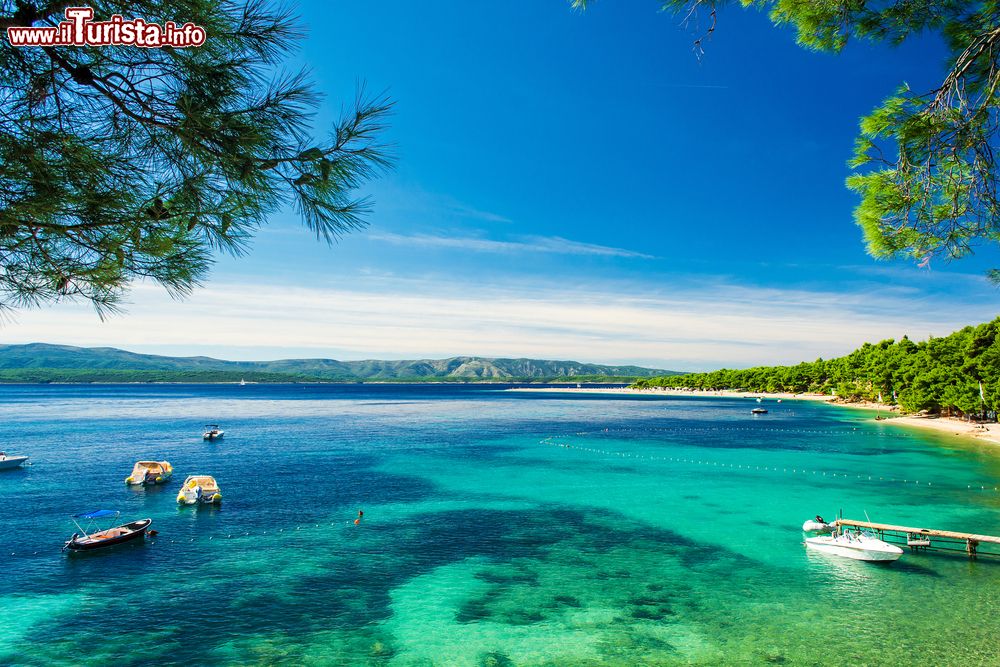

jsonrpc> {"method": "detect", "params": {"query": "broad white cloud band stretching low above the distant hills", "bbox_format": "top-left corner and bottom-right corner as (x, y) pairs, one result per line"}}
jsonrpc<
(0, 279), (994, 369)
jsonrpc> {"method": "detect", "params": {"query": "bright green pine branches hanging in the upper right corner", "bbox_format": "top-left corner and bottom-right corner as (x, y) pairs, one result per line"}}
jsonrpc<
(572, 0), (1000, 284)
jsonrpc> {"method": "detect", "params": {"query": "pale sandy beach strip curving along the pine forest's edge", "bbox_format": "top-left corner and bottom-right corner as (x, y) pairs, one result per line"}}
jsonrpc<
(507, 387), (1000, 445)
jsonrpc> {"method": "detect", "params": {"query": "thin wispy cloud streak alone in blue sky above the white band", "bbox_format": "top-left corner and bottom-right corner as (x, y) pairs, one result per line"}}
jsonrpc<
(368, 232), (655, 259)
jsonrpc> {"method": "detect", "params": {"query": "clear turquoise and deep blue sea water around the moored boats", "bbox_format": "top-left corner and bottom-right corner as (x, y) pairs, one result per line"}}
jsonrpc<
(0, 385), (1000, 666)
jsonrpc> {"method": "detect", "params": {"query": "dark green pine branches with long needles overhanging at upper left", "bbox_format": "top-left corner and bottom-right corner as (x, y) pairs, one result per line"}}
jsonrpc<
(0, 0), (390, 313)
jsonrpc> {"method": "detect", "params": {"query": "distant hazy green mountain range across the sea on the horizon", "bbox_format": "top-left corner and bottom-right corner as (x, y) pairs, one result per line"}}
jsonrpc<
(0, 343), (679, 383)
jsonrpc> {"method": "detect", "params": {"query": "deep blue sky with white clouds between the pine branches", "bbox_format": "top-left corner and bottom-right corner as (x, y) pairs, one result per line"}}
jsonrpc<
(3, 0), (1000, 369)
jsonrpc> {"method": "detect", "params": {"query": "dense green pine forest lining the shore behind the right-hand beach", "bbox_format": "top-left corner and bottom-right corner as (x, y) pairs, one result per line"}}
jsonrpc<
(633, 318), (1000, 416)
